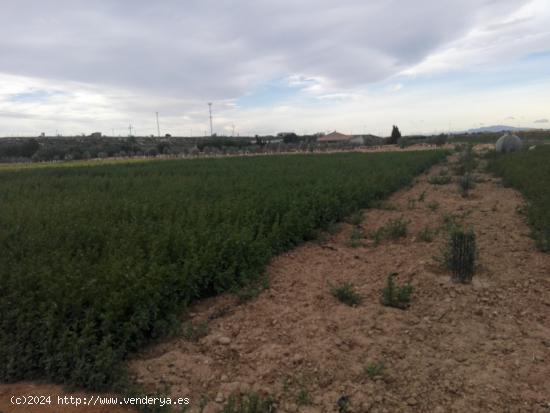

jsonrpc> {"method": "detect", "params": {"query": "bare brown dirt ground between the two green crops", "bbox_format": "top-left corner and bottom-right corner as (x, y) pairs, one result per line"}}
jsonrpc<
(0, 146), (550, 413)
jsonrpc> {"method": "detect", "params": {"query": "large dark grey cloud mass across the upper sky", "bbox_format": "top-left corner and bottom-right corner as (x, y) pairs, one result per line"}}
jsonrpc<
(0, 0), (536, 99)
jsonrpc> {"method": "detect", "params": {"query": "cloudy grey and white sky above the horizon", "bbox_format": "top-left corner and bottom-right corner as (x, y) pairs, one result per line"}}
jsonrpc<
(0, 0), (550, 136)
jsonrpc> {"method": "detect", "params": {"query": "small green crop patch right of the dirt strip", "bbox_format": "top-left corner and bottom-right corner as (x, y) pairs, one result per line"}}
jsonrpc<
(491, 147), (550, 252)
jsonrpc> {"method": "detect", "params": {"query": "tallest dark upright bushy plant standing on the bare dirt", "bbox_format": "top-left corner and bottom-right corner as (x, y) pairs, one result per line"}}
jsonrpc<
(446, 228), (476, 283)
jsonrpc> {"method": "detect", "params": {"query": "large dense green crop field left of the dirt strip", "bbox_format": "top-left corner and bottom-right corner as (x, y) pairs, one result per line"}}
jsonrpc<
(0, 151), (446, 389)
